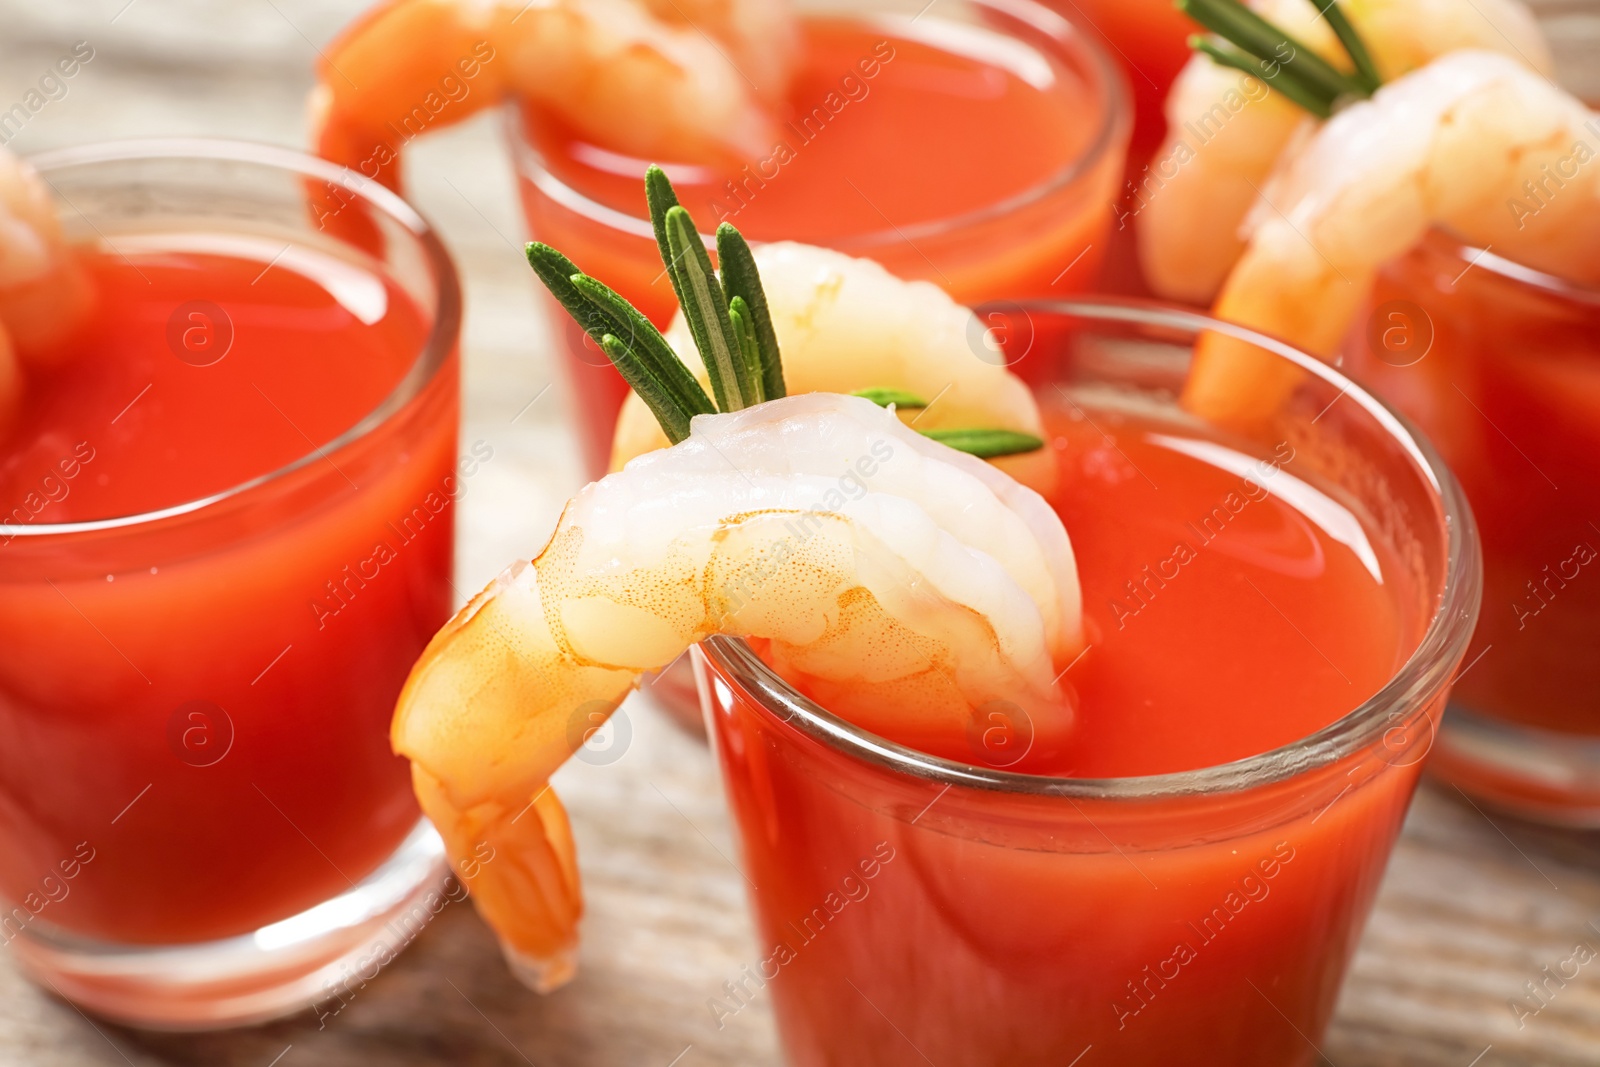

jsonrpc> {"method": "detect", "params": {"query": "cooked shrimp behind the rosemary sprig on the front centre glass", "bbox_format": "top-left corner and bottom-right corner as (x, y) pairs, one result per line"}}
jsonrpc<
(611, 242), (1058, 494)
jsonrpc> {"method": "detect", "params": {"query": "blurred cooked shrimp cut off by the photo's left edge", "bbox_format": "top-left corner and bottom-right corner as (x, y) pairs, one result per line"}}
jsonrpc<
(0, 149), (93, 429)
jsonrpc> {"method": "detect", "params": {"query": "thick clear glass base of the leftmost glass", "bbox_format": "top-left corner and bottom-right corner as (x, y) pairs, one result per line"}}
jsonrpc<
(13, 819), (451, 1030)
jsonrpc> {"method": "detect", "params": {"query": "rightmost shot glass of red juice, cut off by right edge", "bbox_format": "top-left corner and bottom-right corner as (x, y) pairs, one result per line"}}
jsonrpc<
(1349, 234), (1600, 827)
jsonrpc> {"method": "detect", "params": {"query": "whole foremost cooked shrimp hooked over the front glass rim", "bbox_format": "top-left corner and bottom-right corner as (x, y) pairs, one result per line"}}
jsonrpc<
(392, 394), (1083, 989)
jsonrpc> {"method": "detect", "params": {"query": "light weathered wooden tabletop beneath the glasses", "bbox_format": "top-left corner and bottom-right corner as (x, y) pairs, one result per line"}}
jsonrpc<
(0, 0), (1600, 1067)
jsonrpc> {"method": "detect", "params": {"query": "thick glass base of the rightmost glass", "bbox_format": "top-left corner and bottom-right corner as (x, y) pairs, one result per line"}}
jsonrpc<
(1429, 704), (1600, 829)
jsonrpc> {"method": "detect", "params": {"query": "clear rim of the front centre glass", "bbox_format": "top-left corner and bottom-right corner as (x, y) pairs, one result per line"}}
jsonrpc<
(699, 296), (1482, 801)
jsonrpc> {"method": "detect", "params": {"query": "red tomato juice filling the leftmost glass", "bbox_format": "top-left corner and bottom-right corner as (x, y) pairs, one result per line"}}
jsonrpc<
(0, 235), (469, 944)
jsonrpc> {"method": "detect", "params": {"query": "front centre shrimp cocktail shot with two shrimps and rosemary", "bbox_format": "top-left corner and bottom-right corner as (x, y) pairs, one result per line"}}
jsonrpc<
(392, 168), (1478, 1067)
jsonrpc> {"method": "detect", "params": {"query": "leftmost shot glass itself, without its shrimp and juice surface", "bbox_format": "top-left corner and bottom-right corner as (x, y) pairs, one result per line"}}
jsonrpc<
(0, 139), (462, 1029)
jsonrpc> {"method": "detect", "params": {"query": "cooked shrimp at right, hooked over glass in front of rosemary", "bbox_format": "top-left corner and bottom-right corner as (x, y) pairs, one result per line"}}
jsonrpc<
(1186, 51), (1600, 418)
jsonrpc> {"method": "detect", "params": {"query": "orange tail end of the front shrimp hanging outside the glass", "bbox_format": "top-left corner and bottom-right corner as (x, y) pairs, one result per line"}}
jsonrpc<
(390, 561), (638, 992)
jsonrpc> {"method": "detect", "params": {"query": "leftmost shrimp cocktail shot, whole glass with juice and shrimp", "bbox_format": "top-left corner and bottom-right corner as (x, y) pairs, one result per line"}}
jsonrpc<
(0, 141), (475, 1029)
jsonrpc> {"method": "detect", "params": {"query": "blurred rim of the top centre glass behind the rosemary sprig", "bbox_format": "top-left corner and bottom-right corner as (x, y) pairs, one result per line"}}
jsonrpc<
(504, 0), (1133, 254)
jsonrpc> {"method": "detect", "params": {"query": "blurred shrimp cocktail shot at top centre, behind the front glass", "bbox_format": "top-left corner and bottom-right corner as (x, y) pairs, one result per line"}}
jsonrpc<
(312, 0), (1139, 477)
